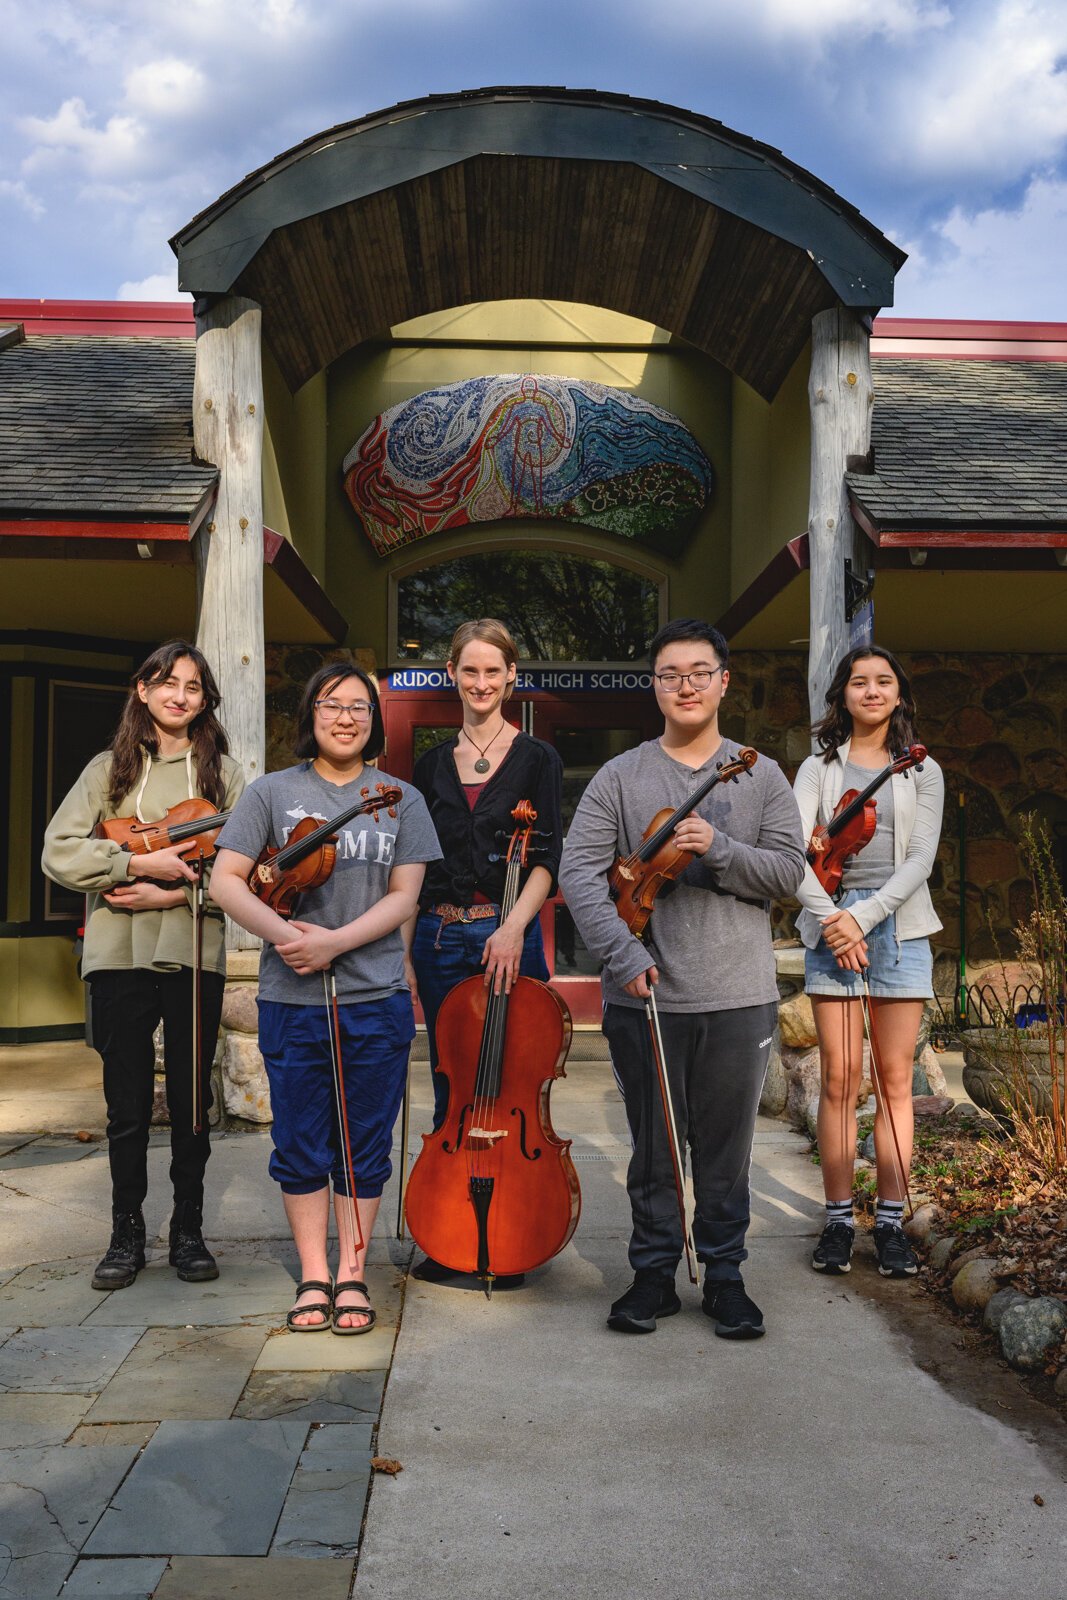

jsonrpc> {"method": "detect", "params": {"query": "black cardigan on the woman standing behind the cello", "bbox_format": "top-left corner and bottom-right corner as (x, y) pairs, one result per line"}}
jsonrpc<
(411, 733), (563, 910)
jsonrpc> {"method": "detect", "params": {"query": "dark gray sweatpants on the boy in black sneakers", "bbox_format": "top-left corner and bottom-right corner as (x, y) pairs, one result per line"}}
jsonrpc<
(603, 1005), (777, 1283)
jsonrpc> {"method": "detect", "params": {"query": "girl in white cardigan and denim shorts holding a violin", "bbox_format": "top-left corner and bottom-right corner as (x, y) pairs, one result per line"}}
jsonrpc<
(793, 646), (944, 1278)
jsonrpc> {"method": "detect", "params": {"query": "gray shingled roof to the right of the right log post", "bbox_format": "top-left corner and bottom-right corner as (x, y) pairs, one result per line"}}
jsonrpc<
(846, 357), (1067, 533)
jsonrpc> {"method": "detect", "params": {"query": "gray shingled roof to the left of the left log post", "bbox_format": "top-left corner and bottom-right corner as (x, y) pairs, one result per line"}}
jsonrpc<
(0, 334), (218, 523)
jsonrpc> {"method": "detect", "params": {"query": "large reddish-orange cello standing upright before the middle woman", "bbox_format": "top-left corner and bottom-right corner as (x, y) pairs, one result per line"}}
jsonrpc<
(406, 800), (581, 1299)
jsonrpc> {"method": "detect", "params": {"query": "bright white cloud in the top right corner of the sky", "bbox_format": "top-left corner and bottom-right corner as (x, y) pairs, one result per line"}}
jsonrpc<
(889, 0), (1067, 184)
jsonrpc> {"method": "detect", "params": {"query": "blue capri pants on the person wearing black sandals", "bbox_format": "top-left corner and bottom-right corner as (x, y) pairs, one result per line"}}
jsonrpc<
(259, 989), (414, 1200)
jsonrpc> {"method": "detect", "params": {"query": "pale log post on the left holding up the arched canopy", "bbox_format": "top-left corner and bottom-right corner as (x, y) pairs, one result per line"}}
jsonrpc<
(192, 296), (266, 949)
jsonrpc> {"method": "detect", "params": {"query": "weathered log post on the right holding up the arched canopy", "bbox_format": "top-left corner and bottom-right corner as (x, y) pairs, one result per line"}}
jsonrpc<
(808, 306), (873, 736)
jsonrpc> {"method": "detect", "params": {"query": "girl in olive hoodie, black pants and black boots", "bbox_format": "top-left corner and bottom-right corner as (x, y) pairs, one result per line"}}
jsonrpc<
(42, 638), (245, 1290)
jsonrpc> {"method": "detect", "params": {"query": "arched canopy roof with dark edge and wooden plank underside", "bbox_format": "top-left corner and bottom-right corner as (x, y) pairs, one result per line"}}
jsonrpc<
(171, 88), (905, 397)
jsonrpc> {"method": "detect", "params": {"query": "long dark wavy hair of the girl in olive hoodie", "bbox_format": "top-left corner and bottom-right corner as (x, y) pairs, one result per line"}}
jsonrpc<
(107, 638), (230, 810)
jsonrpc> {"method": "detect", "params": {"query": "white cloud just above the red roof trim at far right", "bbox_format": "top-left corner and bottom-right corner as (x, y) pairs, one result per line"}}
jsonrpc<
(889, 176), (1067, 322)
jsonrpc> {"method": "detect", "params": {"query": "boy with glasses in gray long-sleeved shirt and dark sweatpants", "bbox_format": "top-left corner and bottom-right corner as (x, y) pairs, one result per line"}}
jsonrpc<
(560, 619), (805, 1339)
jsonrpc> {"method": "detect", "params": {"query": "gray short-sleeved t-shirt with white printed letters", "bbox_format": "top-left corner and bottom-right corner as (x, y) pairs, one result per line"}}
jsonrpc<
(218, 762), (442, 1005)
